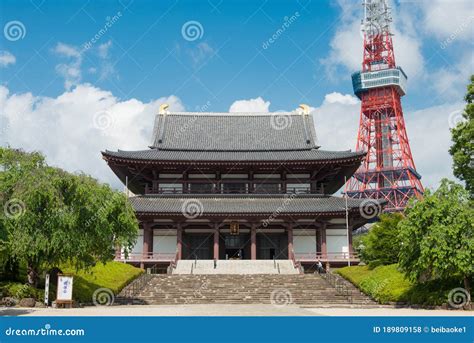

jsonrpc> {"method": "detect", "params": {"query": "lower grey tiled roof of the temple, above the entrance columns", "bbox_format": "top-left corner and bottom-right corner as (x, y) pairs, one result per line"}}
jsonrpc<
(129, 194), (384, 215)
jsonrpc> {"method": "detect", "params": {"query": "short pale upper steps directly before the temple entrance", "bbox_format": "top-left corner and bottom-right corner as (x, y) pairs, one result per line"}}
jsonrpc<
(173, 260), (299, 275)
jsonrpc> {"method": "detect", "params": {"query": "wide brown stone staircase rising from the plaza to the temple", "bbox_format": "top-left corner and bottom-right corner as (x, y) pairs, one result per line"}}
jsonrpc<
(119, 274), (377, 307)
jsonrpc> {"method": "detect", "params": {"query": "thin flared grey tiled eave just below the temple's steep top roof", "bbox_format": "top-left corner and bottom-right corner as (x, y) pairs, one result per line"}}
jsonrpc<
(104, 149), (365, 162)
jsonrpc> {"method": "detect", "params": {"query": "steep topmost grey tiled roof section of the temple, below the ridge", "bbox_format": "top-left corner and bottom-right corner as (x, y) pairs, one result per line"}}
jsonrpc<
(151, 112), (317, 151)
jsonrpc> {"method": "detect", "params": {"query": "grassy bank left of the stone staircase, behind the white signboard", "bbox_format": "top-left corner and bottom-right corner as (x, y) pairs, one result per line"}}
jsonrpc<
(61, 262), (143, 303)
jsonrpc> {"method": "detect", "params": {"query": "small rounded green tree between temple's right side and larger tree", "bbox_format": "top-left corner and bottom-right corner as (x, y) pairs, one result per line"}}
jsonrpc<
(359, 213), (403, 265)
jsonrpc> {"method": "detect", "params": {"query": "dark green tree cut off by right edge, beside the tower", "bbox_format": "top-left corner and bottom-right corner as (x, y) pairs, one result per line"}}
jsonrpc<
(449, 75), (474, 197)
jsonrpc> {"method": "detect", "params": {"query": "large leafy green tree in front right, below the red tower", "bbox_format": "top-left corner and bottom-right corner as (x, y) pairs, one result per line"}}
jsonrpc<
(399, 179), (474, 291)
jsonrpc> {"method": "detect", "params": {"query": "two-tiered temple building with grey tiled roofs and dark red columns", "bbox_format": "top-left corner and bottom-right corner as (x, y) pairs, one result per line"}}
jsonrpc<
(102, 105), (383, 267)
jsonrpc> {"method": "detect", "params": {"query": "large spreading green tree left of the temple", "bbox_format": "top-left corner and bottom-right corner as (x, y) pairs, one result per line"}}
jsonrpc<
(0, 149), (138, 285)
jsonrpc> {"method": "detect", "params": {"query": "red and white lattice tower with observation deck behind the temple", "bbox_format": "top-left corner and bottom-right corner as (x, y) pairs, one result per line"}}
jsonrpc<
(345, 0), (423, 212)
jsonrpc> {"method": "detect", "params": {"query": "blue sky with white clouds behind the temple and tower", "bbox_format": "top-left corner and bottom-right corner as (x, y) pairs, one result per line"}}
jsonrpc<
(0, 0), (474, 186)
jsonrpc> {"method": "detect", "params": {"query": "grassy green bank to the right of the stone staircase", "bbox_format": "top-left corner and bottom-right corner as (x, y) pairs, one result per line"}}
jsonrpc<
(336, 264), (460, 305)
